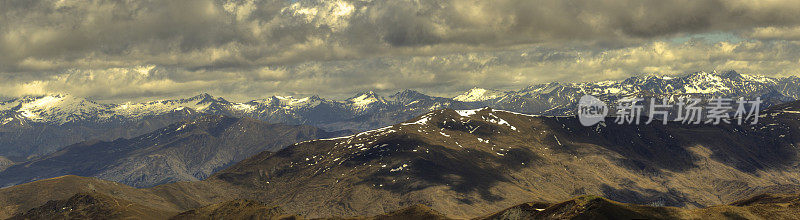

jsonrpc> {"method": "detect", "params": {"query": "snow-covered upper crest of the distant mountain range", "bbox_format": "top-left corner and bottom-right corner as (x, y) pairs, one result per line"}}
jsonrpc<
(7, 71), (800, 127)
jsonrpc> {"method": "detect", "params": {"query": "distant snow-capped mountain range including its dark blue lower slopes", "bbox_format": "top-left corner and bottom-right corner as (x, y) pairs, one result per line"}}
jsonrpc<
(0, 71), (800, 161)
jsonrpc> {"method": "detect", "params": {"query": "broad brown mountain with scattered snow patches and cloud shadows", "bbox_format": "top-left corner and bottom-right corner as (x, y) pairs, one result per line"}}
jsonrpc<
(0, 101), (800, 219)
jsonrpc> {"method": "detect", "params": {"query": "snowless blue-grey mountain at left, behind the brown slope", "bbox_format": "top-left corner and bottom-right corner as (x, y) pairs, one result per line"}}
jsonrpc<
(0, 115), (348, 187)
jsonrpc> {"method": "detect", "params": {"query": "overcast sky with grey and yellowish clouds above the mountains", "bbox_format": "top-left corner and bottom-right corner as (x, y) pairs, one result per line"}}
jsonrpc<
(0, 0), (800, 100)
